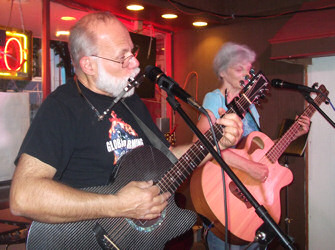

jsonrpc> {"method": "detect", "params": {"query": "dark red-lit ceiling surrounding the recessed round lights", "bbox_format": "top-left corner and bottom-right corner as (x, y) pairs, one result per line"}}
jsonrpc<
(54, 0), (318, 30)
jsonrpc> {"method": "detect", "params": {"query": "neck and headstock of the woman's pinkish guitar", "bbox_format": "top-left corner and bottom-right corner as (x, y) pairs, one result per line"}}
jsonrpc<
(266, 85), (328, 163)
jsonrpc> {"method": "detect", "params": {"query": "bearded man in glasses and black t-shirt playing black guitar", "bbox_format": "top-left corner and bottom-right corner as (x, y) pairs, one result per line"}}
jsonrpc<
(10, 12), (242, 249)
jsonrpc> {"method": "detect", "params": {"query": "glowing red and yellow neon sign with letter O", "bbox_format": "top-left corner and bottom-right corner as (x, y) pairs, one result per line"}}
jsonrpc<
(0, 28), (32, 80)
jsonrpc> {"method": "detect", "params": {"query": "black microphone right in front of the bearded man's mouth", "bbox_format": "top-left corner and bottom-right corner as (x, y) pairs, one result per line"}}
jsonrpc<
(144, 65), (206, 113)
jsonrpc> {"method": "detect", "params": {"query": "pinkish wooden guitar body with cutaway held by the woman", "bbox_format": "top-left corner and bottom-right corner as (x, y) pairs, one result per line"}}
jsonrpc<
(191, 131), (293, 244)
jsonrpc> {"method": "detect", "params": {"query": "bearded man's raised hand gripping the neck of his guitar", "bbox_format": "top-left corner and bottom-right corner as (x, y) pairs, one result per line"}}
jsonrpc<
(216, 108), (243, 150)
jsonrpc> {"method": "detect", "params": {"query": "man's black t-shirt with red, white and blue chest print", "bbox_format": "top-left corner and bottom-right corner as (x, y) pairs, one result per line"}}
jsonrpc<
(18, 81), (168, 187)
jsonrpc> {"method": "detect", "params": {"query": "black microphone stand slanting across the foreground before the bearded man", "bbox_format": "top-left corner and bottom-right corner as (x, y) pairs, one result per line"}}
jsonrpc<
(166, 94), (296, 249)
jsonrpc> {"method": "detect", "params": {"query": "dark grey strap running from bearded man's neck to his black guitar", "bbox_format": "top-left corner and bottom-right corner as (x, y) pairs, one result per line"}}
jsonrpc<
(121, 100), (178, 164)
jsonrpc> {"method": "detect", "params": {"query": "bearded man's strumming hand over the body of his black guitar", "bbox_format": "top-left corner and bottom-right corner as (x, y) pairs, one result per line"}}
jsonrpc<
(116, 181), (171, 220)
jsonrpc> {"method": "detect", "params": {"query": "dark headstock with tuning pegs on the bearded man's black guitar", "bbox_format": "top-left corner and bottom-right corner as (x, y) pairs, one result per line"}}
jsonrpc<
(228, 71), (269, 118)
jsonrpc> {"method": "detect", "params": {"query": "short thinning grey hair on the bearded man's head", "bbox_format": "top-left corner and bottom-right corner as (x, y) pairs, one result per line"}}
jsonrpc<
(69, 12), (117, 68)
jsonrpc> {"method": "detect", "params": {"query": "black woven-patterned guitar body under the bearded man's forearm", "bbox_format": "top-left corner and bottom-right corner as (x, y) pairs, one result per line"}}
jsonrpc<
(27, 146), (197, 250)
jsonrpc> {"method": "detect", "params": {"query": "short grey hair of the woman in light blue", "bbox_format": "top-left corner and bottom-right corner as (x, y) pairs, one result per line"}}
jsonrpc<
(213, 42), (256, 78)
